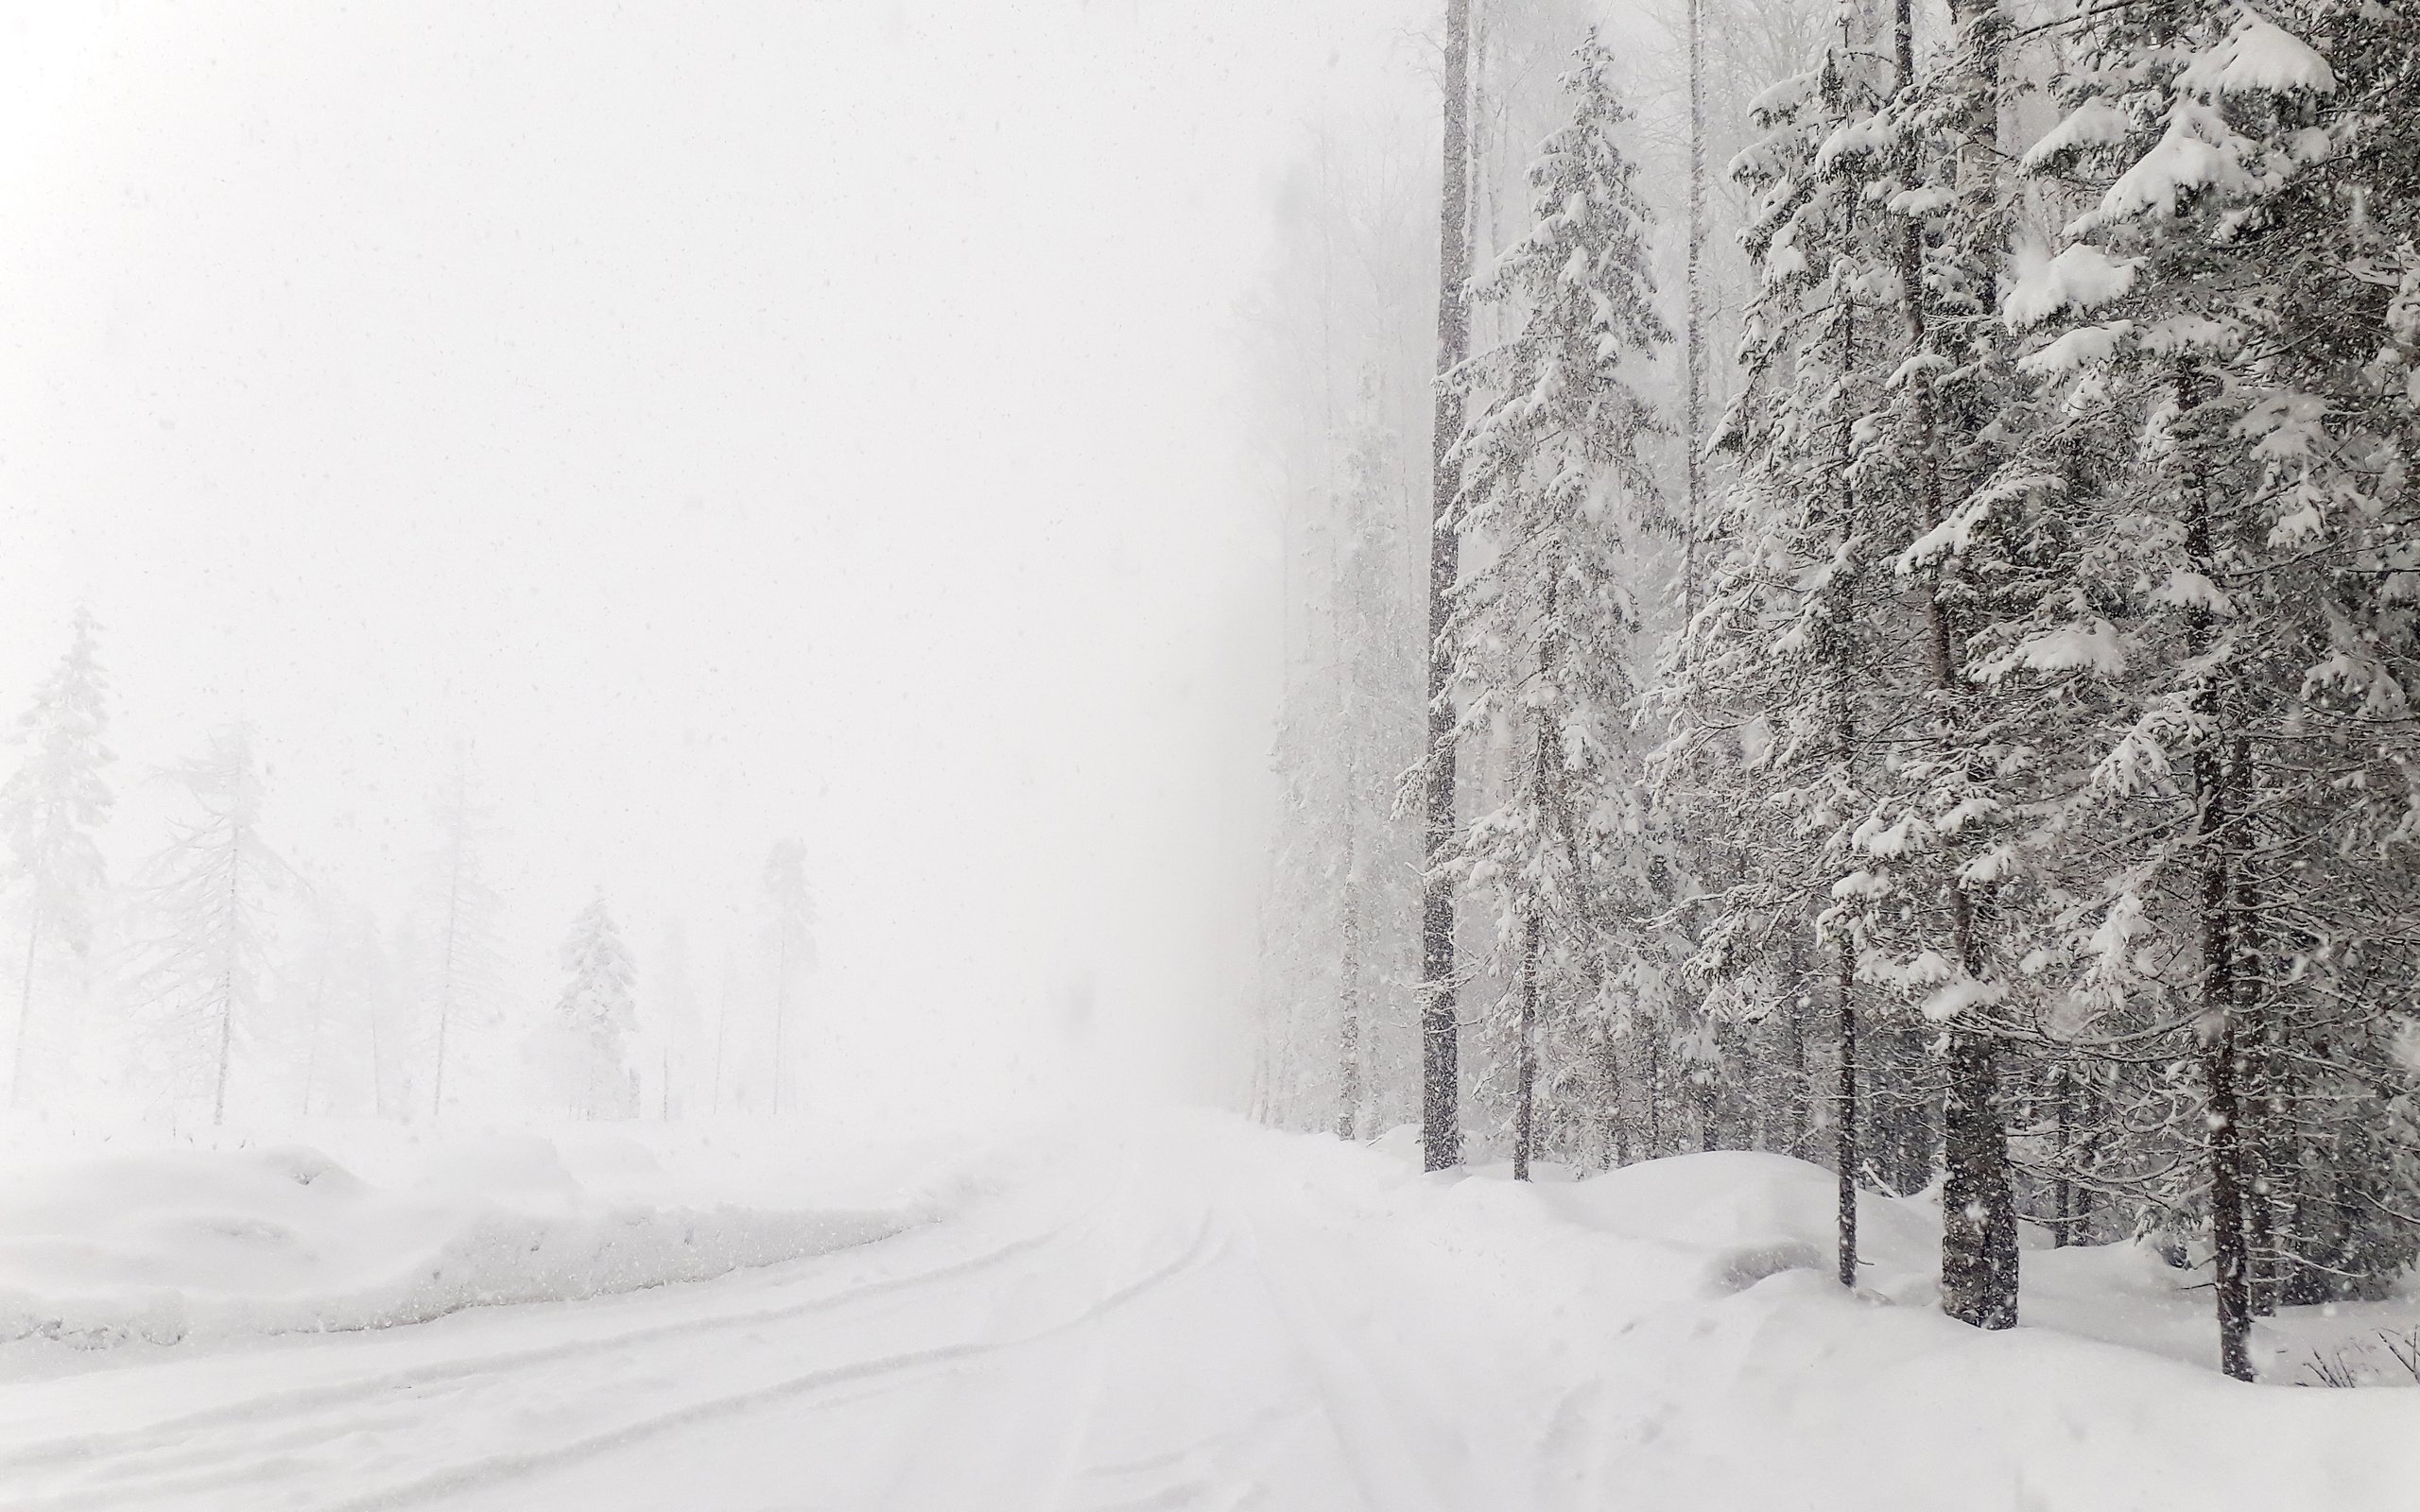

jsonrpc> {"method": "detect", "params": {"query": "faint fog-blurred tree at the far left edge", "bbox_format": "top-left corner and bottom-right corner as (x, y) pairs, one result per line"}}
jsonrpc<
(0, 610), (113, 1106)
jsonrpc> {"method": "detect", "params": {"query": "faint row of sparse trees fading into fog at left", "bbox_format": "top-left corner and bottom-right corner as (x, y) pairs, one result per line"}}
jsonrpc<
(0, 612), (816, 1127)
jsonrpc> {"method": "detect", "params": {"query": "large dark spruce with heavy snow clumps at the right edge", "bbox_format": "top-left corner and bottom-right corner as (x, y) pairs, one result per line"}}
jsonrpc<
(2011, 0), (2420, 1379)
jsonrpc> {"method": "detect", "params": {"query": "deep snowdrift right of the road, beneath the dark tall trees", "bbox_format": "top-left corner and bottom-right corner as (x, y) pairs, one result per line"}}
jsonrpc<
(1336, 1137), (2420, 1512)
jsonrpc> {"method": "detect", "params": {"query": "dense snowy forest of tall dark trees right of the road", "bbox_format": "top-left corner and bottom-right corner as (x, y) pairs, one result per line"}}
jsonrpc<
(1253, 0), (2420, 1379)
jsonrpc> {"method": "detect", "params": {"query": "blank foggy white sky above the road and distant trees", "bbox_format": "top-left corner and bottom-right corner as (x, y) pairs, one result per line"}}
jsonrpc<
(0, 0), (1421, 1126)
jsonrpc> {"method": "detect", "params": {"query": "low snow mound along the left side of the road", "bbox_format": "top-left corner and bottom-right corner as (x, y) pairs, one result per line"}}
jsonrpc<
(0, 1137), (912, 1348)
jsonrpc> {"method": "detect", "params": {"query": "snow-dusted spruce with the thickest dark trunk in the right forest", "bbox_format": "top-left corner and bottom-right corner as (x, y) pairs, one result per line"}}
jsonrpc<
(1827, 0), (2038, 1328)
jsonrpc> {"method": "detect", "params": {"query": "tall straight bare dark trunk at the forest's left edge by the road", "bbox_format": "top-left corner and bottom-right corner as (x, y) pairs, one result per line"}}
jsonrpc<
(1421, 0), (1471, 1171)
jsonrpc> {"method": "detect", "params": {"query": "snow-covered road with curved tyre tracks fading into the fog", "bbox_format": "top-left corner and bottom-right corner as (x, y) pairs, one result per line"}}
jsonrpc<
(0, 1122), (1567, 1512)
